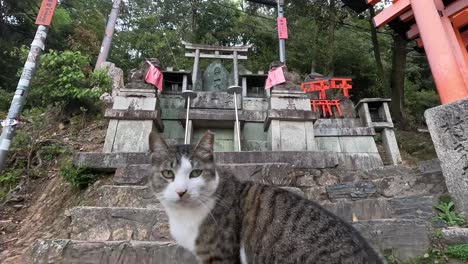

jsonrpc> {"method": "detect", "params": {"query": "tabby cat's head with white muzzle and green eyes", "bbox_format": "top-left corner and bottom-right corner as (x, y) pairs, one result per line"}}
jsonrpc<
(149, 131), (218, 207)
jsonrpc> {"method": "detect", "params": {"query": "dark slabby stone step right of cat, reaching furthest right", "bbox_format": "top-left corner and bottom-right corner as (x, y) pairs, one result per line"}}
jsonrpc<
(325, 171), (447, 200)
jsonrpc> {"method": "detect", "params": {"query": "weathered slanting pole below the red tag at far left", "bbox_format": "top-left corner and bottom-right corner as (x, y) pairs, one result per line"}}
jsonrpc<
(0, 25), (49, 171)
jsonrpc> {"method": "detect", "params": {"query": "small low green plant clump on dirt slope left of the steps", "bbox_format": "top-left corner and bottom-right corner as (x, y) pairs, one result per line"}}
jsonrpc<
(59, 163), (99, 189)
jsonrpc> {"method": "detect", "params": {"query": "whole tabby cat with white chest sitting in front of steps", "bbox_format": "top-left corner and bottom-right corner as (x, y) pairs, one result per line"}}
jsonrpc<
(150, 132), (383, 264)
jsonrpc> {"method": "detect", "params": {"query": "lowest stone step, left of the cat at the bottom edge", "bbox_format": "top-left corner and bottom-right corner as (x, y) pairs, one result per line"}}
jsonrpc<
(26, 240), (197, 264)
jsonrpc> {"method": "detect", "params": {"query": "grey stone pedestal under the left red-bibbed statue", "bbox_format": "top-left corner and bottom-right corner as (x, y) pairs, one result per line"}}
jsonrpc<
(103, 84), (164, 153)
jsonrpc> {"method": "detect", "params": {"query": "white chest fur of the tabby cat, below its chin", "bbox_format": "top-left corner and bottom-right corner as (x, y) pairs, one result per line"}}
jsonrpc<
(166, 201), (214, 253)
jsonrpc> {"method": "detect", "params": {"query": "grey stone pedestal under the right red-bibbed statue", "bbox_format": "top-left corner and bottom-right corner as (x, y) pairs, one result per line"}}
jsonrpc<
(265, 90), (317, 151)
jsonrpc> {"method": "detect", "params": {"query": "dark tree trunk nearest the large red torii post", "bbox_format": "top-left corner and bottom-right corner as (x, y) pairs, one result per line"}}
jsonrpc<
(391, 34), (408, 127)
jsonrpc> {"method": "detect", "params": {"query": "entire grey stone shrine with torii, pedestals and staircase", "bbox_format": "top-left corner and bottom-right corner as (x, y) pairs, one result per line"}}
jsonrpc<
(24, 43), (447, 264)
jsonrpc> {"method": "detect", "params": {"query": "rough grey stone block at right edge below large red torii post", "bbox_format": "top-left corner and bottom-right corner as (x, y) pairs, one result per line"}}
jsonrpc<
(425, 99), (468, 213)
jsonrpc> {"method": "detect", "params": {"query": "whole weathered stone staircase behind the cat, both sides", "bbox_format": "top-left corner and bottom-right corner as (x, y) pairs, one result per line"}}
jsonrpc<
(27, 153), (446, 264)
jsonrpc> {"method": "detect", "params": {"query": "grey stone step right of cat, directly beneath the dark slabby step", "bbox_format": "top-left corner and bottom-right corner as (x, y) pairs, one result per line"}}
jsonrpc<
(322, 195), (437, 223)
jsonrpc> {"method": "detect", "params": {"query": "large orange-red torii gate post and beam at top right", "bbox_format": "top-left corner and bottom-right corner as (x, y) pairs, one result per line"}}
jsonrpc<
(342, 0), (468, 104)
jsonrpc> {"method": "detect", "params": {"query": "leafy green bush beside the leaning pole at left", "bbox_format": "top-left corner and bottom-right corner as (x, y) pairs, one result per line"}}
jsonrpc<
(28, 50), (111, 114)
